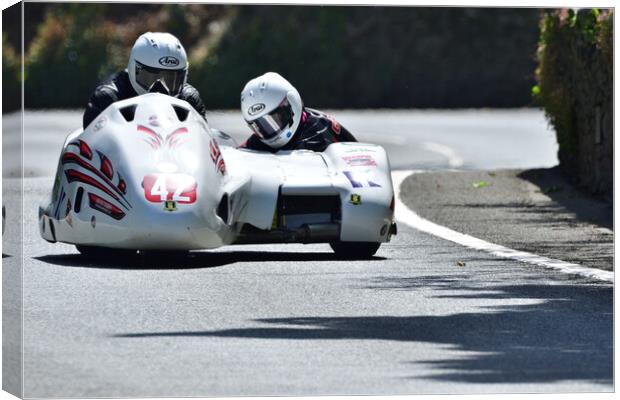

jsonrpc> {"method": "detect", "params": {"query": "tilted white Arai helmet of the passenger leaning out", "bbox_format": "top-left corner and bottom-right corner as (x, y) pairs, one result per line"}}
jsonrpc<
(241, 72), (303, 149)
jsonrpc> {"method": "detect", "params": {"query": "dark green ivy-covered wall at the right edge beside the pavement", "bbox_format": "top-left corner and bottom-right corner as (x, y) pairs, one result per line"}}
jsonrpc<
(532, 9), (613, 193)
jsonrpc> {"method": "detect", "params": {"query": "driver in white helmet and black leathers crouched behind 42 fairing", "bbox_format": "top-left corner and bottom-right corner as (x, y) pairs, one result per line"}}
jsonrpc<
(83, 32), (206, 128)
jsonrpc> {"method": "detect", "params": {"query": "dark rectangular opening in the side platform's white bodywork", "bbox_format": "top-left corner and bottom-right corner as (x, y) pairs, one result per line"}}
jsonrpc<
(278, 195), (341, 229)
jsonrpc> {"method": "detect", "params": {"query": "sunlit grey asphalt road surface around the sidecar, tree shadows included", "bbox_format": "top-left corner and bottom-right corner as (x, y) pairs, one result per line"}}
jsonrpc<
(3, 110), (613, 397)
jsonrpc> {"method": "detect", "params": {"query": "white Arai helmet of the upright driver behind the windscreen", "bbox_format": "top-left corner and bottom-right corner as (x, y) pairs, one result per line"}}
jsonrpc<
(127, 32), (188, 96)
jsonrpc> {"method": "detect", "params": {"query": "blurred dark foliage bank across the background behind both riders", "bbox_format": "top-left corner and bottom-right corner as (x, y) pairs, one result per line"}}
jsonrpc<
(3, 3), (540, 109)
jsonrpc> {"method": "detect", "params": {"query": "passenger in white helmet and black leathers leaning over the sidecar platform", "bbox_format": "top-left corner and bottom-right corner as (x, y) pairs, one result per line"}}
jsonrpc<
(240, 72), (356, 153)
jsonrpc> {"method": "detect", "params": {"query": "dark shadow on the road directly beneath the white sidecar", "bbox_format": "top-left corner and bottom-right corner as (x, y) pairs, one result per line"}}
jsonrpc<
(35, 251), (385, 270)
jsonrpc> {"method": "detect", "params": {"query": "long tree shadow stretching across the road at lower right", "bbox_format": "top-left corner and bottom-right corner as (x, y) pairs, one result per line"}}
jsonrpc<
(114, 275), (613, 384)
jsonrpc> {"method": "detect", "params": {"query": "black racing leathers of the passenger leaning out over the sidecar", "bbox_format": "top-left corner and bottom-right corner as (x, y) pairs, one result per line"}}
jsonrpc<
(239, 107), (357, 153)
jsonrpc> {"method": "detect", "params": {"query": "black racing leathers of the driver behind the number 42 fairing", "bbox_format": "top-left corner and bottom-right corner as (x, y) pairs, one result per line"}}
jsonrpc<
(82, 70), (207, 128)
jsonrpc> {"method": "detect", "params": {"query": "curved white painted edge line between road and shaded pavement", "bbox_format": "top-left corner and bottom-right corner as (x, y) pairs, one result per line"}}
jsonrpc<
(392, 171), (614, 283)
